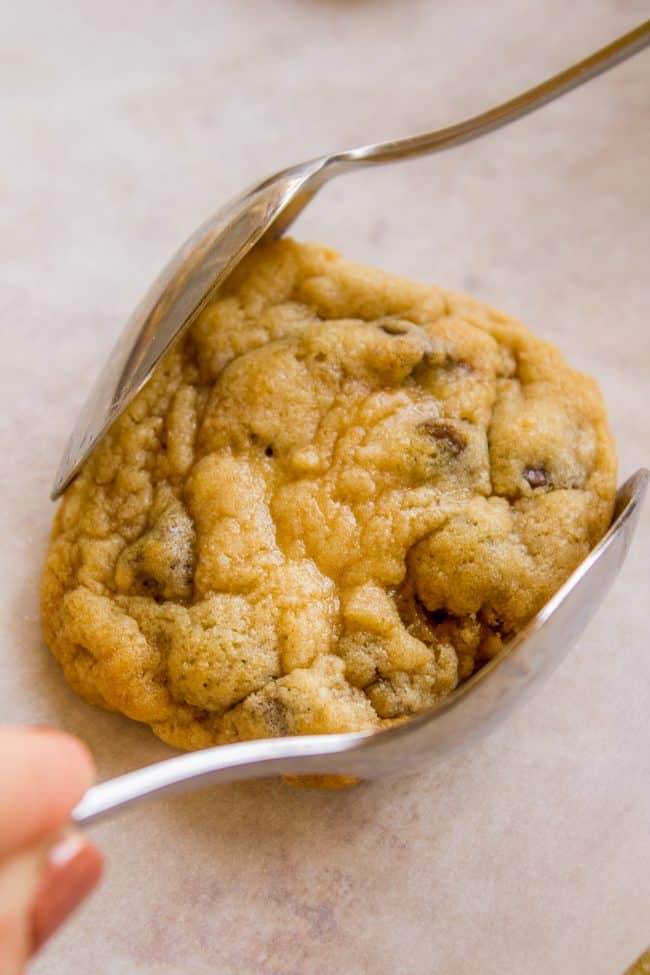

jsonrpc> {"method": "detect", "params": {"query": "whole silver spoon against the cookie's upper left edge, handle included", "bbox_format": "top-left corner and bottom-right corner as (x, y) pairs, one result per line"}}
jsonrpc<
(52, 20), (650, 499)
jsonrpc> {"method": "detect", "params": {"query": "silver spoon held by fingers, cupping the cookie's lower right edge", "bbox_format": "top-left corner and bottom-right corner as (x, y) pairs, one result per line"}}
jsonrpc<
(72, 470), (650, 824)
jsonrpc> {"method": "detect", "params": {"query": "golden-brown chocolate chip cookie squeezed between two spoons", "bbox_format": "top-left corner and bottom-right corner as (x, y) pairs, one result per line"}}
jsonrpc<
(42, 240), (616, 748)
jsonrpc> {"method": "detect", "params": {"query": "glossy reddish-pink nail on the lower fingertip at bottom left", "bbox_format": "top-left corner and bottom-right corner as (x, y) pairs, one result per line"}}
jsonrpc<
(32, 833), (104, 951)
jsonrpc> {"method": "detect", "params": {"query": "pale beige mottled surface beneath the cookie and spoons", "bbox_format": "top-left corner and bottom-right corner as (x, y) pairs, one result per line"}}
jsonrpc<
(0, 0), (650, 975)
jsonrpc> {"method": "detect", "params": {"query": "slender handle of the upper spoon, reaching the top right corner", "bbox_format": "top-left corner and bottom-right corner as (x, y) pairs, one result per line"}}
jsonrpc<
(335, 20), (650, 165)
